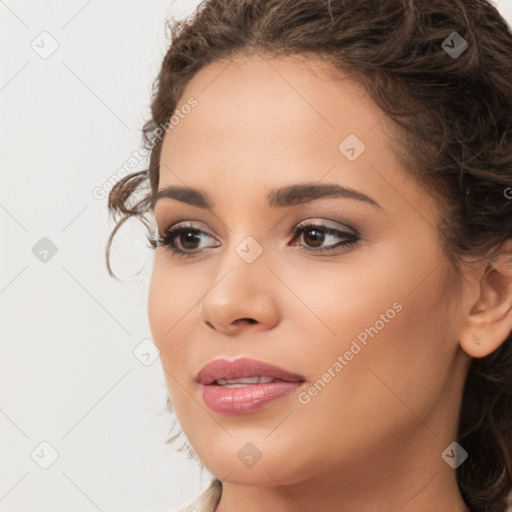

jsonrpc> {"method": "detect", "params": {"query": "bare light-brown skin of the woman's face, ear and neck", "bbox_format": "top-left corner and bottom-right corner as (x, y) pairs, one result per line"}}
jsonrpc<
(148, 55), (512, 512)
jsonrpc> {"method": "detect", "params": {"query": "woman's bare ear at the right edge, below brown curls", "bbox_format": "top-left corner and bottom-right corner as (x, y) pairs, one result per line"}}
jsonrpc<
(459, 239), (512, 358)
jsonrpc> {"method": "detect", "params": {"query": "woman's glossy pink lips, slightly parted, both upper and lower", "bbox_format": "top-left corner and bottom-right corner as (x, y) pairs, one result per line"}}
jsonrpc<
(196, 358), (305, 414)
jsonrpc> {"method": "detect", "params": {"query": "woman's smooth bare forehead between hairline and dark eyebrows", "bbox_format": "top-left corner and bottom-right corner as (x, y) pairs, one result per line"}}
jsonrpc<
(159, 55), (420, 216)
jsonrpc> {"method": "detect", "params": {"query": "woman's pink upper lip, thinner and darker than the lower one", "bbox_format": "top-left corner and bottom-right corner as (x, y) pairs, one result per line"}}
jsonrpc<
(196, 357), (305, 385)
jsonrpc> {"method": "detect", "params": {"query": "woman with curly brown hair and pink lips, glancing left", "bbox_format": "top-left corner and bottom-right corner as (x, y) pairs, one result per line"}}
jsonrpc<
(107, 0), (512, 512)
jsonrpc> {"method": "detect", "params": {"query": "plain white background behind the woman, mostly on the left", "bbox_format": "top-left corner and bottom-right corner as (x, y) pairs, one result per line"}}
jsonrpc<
(0, 0), (512, 512)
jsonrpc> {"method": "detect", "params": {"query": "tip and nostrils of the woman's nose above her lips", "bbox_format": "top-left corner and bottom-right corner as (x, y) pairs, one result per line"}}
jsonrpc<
(199, 260), (279, 336)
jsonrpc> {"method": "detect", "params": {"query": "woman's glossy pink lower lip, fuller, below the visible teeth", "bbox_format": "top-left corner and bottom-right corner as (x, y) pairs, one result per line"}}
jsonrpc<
(202, 381), (303, 414)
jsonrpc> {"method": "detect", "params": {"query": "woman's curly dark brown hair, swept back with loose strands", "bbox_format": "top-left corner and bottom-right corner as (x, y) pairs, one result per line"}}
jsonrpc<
(106, 0), (512, 512)
